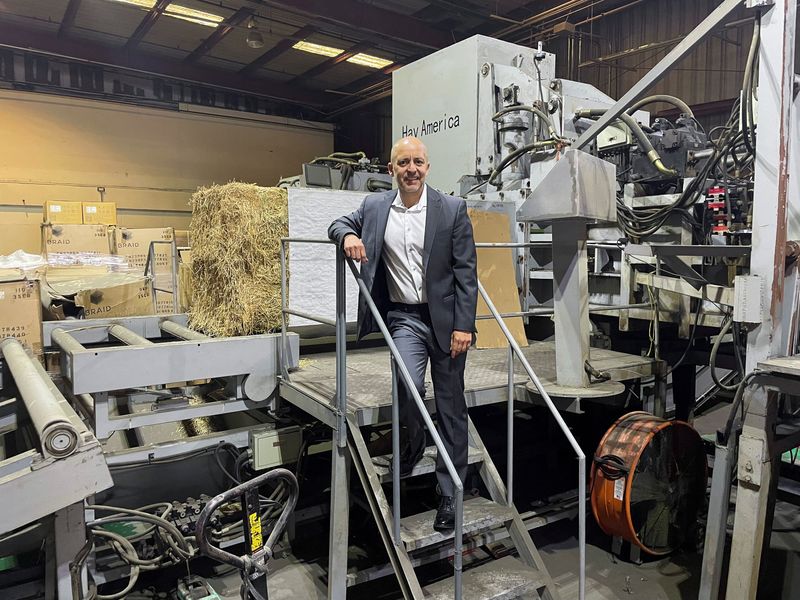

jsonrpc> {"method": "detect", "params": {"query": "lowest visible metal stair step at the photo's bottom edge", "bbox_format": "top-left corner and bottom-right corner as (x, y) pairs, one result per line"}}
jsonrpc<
(424, 556), (544, 600)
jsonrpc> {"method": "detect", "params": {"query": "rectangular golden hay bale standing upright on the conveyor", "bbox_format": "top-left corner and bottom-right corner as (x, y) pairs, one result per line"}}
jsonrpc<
(189, 182), (289, 336)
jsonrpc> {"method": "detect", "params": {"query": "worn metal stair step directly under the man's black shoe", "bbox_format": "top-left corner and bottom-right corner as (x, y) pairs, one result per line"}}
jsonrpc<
(400, 497), (513, 552)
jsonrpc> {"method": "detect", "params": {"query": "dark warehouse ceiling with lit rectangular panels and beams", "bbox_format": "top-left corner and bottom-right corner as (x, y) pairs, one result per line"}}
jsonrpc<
(0, 0), (645, 117)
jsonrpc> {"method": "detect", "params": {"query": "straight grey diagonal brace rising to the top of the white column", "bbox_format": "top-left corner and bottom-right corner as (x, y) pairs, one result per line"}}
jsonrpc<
(573, 0), (742, 150)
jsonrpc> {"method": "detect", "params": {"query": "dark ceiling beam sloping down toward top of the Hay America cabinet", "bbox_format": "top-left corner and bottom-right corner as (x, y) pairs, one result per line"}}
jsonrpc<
(264, 0), (456, 50)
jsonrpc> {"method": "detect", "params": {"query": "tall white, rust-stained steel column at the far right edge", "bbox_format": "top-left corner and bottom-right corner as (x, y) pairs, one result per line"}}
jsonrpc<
(727, 0), (797, 599)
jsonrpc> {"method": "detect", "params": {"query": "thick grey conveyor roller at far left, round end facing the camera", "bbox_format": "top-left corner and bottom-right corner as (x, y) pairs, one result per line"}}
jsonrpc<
(0, 338), (80, 458)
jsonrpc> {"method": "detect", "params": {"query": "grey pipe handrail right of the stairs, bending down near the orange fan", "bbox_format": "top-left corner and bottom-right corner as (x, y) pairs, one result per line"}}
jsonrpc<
(478, 279), (586, 600)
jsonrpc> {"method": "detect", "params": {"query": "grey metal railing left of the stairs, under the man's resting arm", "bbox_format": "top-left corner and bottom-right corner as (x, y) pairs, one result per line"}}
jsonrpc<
(281, 238), (464, 600)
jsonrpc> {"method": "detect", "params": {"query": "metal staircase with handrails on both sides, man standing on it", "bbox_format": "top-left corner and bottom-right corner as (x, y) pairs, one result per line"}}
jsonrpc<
(281, 238), (586, 600)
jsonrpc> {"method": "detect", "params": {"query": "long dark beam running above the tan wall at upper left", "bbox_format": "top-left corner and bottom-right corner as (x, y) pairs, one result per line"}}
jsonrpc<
(0, 23), (338, 107)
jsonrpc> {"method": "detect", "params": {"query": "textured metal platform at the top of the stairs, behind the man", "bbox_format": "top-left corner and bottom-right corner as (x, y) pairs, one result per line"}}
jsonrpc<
(281, 342), (654, 427)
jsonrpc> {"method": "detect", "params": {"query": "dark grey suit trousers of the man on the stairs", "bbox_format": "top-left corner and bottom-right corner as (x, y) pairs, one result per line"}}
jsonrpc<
(387, 305), (468, 496)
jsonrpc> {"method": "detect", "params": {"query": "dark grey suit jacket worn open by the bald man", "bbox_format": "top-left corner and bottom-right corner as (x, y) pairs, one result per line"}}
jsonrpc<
(328, 186), (478, 352)
